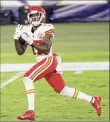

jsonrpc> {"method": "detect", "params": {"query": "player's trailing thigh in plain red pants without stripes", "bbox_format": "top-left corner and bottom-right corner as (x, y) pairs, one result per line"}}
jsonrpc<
(45, 72), (65, 93)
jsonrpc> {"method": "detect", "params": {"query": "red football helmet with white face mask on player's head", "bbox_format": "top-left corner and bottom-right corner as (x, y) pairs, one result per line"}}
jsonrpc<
(27, 6), (46, 26)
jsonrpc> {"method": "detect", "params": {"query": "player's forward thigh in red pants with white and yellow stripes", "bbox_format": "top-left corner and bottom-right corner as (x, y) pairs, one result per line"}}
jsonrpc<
(24, 56), (57, 81)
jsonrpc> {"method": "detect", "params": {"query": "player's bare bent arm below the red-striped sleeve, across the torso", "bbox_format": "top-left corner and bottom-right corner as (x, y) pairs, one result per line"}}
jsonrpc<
(31, 34), (53, 55)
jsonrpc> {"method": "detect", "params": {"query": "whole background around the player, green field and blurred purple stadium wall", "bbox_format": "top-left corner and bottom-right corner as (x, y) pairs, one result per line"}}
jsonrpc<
(0, 0), (110, 121)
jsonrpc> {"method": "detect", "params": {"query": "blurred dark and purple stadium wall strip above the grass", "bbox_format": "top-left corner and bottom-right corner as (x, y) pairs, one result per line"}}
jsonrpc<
(0, 0), (109, 24)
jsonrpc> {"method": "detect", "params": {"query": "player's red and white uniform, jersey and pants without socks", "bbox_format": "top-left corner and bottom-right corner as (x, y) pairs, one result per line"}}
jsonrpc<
(24, 24), (65, 92)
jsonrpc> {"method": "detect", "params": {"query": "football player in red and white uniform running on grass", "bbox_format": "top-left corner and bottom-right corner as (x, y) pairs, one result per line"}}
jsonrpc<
(14, 6), (101, 120)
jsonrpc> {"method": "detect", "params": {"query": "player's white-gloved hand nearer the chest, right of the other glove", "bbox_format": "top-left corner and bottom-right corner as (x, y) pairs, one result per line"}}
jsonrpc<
(21, 31), (33, 45)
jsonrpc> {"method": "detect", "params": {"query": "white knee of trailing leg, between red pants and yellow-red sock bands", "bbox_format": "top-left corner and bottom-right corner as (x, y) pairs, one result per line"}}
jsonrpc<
(60, 86), (75, 97)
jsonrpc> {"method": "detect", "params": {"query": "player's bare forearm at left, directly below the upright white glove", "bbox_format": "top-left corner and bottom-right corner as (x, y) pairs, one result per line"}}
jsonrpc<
(14, 40), (27, 55)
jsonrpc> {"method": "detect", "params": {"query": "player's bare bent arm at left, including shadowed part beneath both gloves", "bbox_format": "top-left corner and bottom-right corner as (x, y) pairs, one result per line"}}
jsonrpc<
(14, 37), (28, 55)
